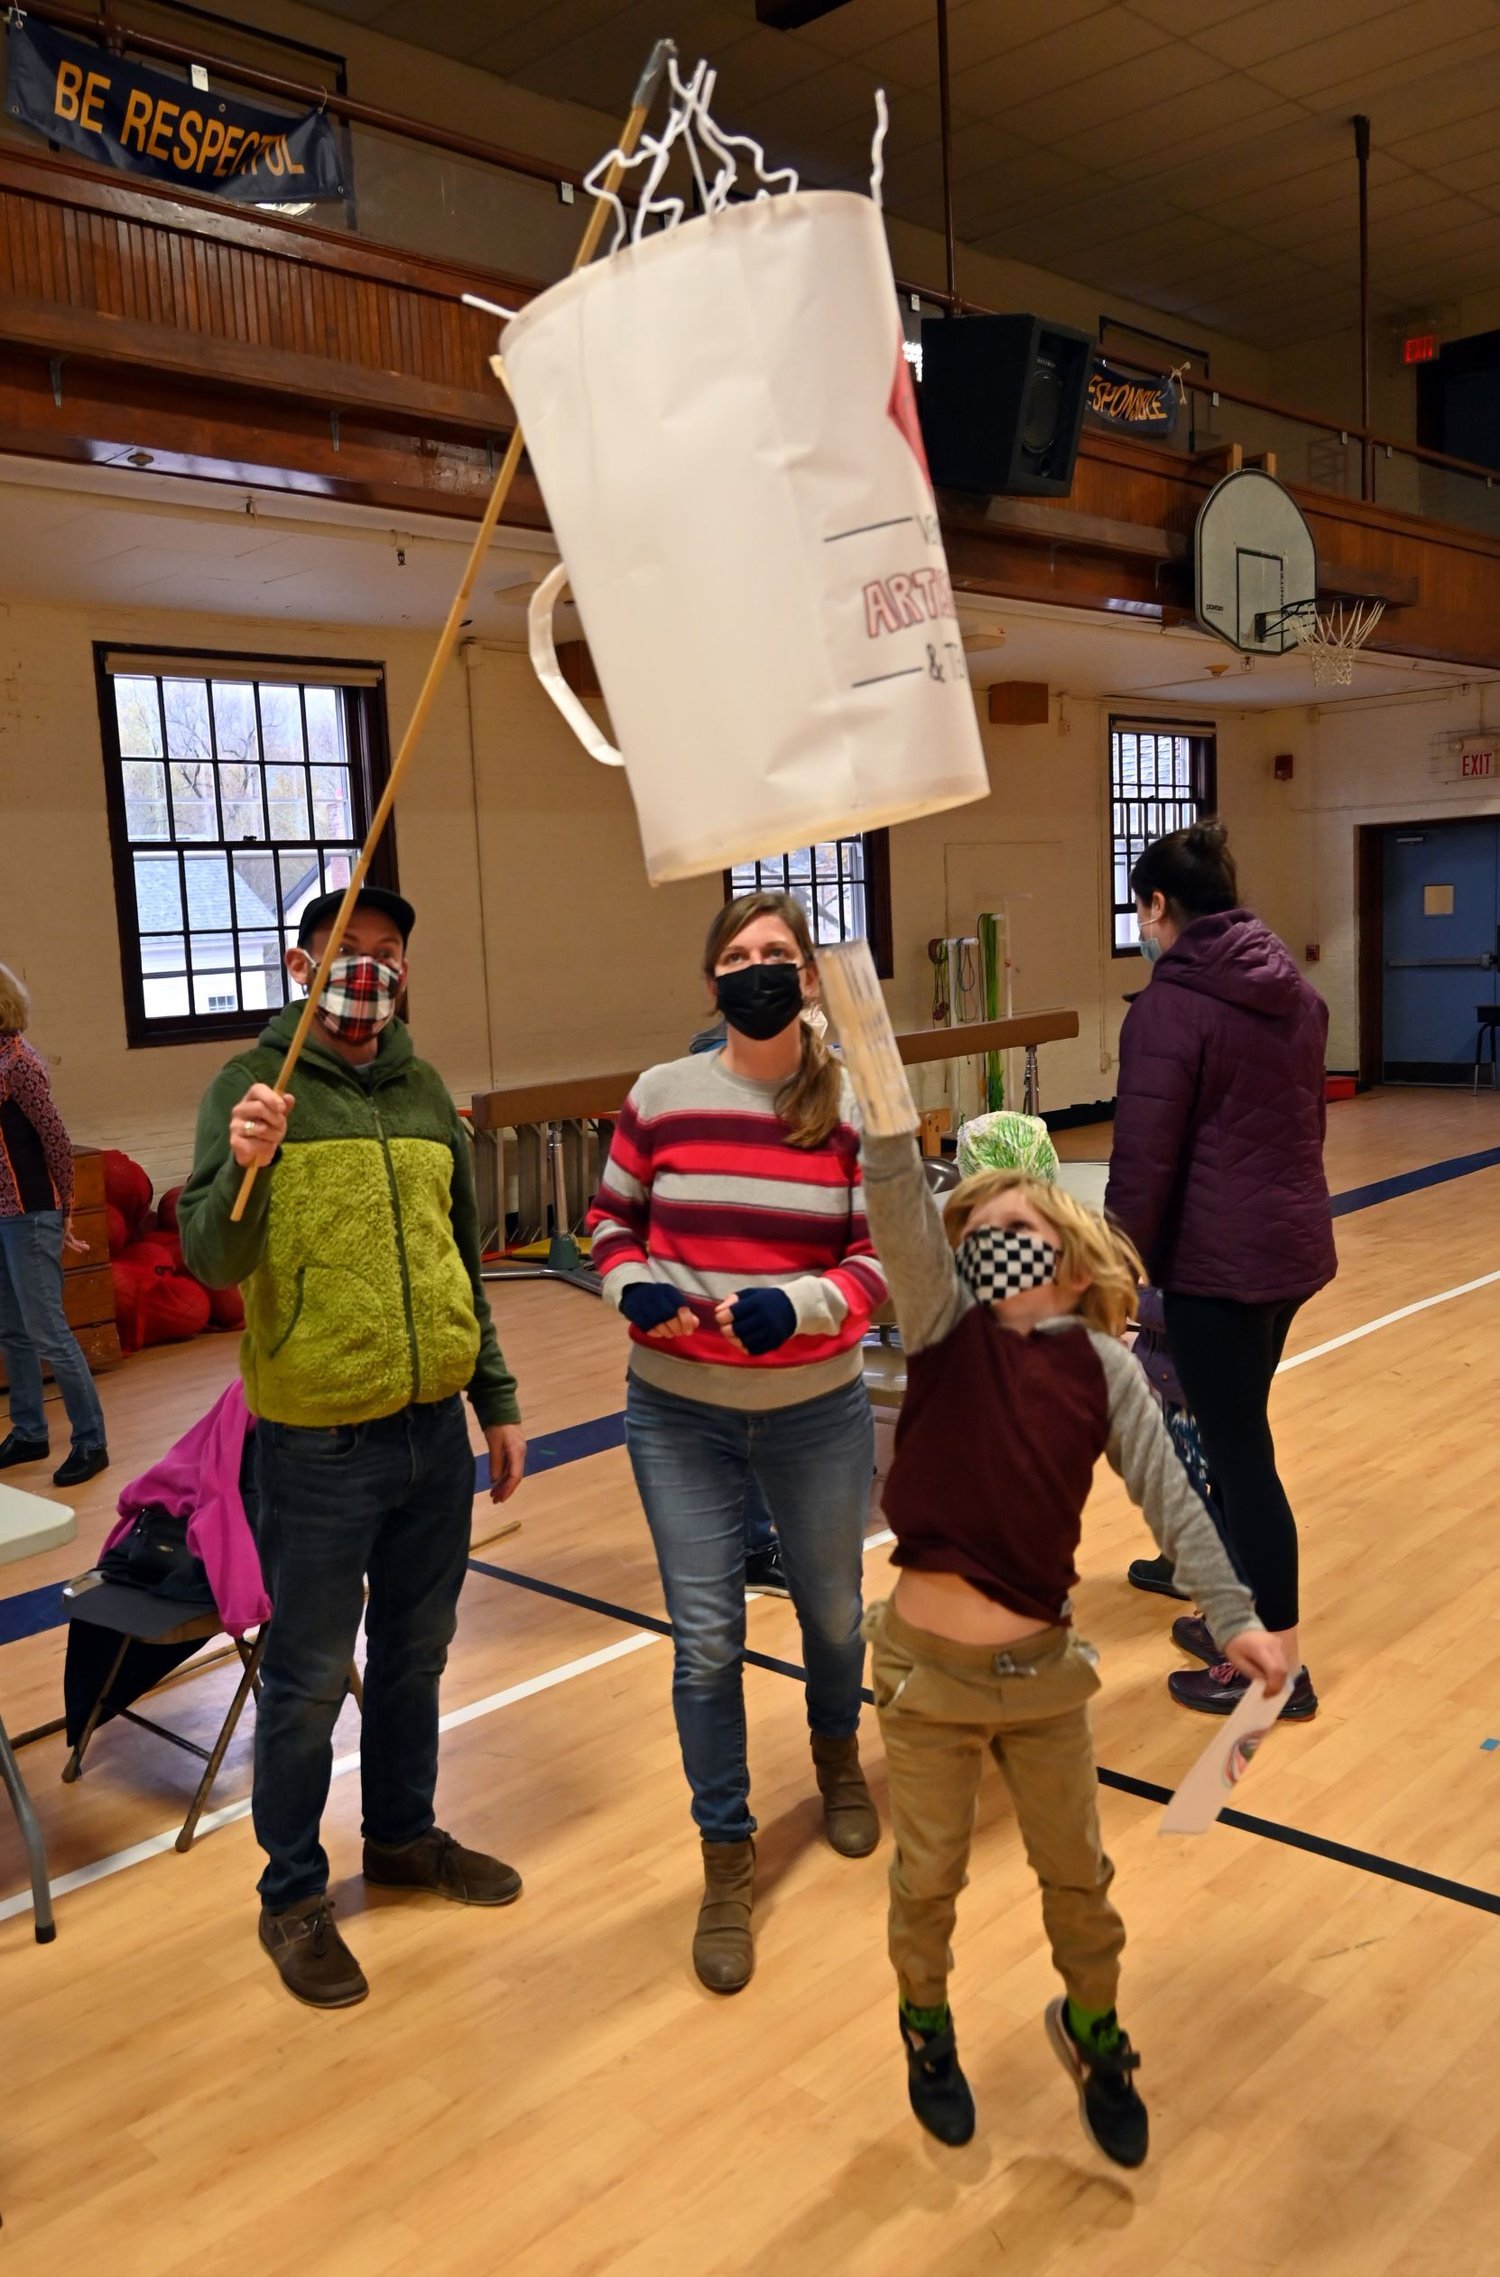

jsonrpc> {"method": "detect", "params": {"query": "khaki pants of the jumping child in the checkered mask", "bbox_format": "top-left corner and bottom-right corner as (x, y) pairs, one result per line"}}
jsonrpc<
(865, 1601), (1124, 2008)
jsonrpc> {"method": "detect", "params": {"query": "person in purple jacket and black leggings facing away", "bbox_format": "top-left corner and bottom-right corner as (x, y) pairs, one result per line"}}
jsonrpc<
(1106, 822), (1338, 1721)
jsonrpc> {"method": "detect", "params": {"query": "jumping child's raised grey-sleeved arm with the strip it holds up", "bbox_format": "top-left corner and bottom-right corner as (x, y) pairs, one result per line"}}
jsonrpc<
(817, 940), (974, 1353)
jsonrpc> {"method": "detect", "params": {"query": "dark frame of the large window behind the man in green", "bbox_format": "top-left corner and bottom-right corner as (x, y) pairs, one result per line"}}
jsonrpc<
(93, 640), (398, 1052)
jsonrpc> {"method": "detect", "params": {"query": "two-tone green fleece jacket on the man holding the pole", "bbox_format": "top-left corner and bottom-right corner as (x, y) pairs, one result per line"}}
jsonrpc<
(178, 1004), (521, 1430)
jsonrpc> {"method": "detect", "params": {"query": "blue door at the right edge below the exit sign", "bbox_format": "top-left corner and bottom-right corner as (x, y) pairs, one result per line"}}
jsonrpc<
(1384, 820), (1500, 1084)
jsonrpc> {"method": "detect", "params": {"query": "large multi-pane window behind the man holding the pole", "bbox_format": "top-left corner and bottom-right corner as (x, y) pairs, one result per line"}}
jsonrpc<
(98, 649), (396, 1045)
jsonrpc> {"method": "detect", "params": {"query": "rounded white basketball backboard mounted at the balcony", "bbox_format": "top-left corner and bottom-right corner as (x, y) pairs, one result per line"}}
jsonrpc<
(1193, 467), (1318, 656)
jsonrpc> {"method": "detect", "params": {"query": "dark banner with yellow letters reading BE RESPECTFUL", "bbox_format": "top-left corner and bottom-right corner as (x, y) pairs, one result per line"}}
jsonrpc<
(5, 16), (344, 205)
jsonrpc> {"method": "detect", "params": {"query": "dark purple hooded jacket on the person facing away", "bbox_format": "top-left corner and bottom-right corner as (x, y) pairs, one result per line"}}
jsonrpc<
(1106, 909), (1338, 1305)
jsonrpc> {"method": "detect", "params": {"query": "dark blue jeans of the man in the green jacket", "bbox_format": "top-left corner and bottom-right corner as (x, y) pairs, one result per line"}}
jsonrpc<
(253, 1396), (473, 1906)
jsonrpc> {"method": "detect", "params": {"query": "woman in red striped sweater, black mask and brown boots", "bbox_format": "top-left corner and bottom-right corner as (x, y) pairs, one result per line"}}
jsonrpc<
(590, 893), (885, 1992)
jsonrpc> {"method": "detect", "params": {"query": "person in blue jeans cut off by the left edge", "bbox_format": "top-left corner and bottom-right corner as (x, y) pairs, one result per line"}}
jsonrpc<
(0, 965), (109, 1487)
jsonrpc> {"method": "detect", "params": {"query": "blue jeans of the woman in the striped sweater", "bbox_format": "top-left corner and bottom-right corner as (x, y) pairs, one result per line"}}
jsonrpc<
(626, 1375), (874, 1842)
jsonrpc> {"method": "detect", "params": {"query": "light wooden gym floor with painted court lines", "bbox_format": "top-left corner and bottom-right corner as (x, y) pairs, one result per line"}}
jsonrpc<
(0, 1093), (1500, 2277)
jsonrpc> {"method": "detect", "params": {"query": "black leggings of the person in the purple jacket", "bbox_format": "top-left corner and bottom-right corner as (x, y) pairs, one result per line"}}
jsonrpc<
(1165, 1291), (1302, 1628)
